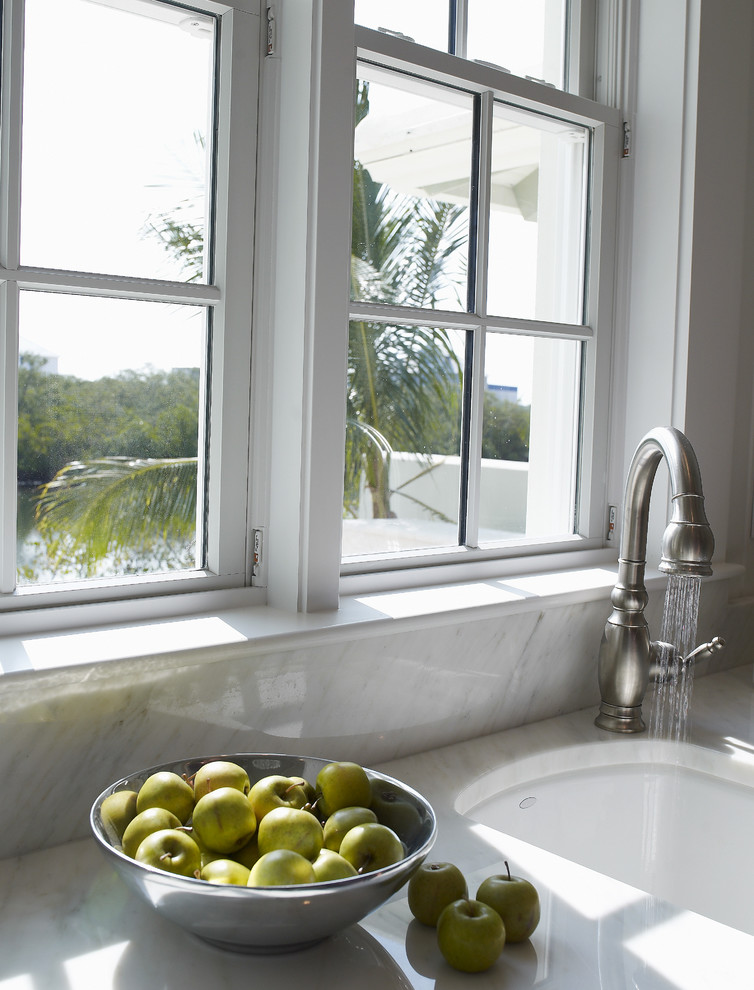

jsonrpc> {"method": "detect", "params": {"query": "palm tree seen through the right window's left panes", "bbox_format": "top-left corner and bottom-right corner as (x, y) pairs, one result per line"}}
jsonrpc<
(344, 83), (468, 518)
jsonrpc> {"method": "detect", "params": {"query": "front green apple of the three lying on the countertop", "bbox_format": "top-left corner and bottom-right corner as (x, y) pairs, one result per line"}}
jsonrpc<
(437, 898), (505, 973)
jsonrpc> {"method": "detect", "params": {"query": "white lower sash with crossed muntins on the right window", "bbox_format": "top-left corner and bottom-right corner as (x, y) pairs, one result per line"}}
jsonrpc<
(341, 26), (621, 577)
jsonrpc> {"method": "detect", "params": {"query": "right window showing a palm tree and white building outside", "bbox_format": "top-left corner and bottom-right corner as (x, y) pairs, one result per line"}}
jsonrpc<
(343, 7), (619, 573)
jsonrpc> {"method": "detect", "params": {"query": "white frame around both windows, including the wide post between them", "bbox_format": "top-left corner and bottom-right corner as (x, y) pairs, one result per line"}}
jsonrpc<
(0, 0), (622, 632)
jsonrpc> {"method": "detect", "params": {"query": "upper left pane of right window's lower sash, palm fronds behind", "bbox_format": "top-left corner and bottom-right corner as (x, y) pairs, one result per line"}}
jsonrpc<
(352, 67), (473, 310)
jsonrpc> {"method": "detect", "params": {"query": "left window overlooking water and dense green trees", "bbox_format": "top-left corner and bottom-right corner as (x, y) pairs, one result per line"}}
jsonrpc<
(0, 0), (260, 606)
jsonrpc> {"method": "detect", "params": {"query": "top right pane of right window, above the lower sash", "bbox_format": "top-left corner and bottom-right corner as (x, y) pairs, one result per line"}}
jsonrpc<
(467, 0), (566, 87)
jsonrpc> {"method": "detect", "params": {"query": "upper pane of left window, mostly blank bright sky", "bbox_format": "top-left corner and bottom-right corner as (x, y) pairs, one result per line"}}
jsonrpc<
(21, 0), (214, 281)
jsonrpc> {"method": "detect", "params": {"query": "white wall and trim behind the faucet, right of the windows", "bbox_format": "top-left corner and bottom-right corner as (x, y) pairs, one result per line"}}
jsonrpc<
(612, 0), (754, 586)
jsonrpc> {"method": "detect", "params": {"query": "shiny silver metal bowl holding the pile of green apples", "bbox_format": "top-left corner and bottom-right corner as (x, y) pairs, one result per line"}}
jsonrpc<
(90, 753), (437, 952)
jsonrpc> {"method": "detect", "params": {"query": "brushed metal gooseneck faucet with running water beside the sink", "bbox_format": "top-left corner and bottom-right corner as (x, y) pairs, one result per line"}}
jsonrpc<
(595, 427), (715, 732)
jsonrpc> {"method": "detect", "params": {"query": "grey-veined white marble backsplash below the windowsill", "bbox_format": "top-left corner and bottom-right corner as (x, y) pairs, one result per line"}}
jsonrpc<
(0, 581), (754, 858)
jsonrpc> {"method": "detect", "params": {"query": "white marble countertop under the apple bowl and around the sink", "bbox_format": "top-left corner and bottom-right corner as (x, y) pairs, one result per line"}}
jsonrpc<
(0, 667), (754, 990)
